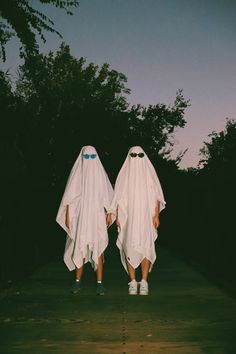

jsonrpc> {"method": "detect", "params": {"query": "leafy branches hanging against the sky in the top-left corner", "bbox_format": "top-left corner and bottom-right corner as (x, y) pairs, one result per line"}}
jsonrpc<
(0, 0), (79, 61)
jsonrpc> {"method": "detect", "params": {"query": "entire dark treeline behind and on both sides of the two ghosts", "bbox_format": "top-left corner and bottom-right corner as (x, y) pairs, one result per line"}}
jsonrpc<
(0, 44), (236, 288)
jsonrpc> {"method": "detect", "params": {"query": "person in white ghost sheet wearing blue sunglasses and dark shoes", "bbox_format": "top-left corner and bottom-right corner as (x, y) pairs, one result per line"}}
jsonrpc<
(56, 146), (113, 295)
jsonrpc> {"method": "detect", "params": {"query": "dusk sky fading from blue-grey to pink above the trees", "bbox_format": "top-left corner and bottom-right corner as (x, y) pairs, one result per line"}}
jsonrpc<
(1, 0), (236, 168)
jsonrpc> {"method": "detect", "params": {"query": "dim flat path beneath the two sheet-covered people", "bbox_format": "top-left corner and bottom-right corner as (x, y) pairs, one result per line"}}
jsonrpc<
(0, 243), (236, 354)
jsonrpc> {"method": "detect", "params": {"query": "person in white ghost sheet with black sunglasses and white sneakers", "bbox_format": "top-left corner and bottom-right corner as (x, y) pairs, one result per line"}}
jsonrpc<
(109, 146), (166, 295)
